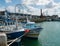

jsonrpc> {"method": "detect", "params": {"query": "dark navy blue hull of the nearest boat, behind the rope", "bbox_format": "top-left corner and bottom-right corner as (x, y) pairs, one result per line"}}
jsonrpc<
(6, 31), (25, 39)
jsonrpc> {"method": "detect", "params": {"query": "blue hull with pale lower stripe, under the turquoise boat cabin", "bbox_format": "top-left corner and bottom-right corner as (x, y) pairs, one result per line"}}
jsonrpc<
(25, 28), (42, 39)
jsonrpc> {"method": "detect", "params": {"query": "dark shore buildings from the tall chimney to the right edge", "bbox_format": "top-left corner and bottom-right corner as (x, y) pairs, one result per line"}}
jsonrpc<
(40, 9), (60, 21)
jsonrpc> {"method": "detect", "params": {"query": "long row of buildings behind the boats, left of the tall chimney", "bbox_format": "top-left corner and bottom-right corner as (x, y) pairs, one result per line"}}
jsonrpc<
(0, 11), (40, 21)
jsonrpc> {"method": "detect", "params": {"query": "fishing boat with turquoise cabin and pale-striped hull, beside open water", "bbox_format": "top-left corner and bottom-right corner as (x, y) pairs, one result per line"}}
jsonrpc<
(24, 18), (42, 38)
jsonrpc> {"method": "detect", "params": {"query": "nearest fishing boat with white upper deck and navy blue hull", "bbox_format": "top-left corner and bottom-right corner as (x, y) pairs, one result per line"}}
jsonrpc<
(0, 11), (27, 40)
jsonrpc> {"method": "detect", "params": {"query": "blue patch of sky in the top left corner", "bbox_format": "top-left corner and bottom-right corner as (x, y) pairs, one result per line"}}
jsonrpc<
(0, 0), (22, 7)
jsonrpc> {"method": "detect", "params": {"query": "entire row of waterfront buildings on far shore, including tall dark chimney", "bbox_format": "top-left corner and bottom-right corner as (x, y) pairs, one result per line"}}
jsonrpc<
(0, 9), (60, 23)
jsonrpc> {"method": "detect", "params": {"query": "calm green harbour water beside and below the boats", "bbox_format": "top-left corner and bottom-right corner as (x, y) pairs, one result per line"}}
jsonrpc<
(22, 22), (60, 46)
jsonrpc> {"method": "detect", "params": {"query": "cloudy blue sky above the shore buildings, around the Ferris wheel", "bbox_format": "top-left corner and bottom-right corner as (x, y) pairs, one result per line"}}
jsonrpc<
(0, 0), (60, 15)
